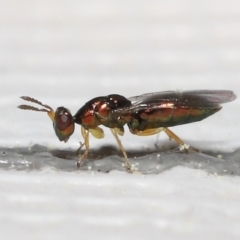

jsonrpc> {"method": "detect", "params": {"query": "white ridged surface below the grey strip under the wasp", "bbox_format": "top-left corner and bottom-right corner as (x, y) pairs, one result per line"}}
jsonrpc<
(0, 167), (240, 240)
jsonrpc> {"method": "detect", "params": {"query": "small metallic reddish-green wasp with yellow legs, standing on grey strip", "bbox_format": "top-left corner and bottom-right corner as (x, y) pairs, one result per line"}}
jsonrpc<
(18, 90), (236, 172)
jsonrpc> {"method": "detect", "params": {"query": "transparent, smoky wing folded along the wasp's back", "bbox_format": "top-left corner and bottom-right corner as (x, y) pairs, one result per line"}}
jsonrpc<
(113, 90), (236, 116)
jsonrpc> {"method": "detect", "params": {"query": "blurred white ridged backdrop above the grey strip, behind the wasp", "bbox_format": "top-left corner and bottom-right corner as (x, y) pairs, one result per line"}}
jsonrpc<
(0, 0), (240, 149)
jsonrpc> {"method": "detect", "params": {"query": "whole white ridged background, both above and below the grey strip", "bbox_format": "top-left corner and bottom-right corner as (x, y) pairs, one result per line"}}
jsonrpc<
(0, 0), (240, 240)
